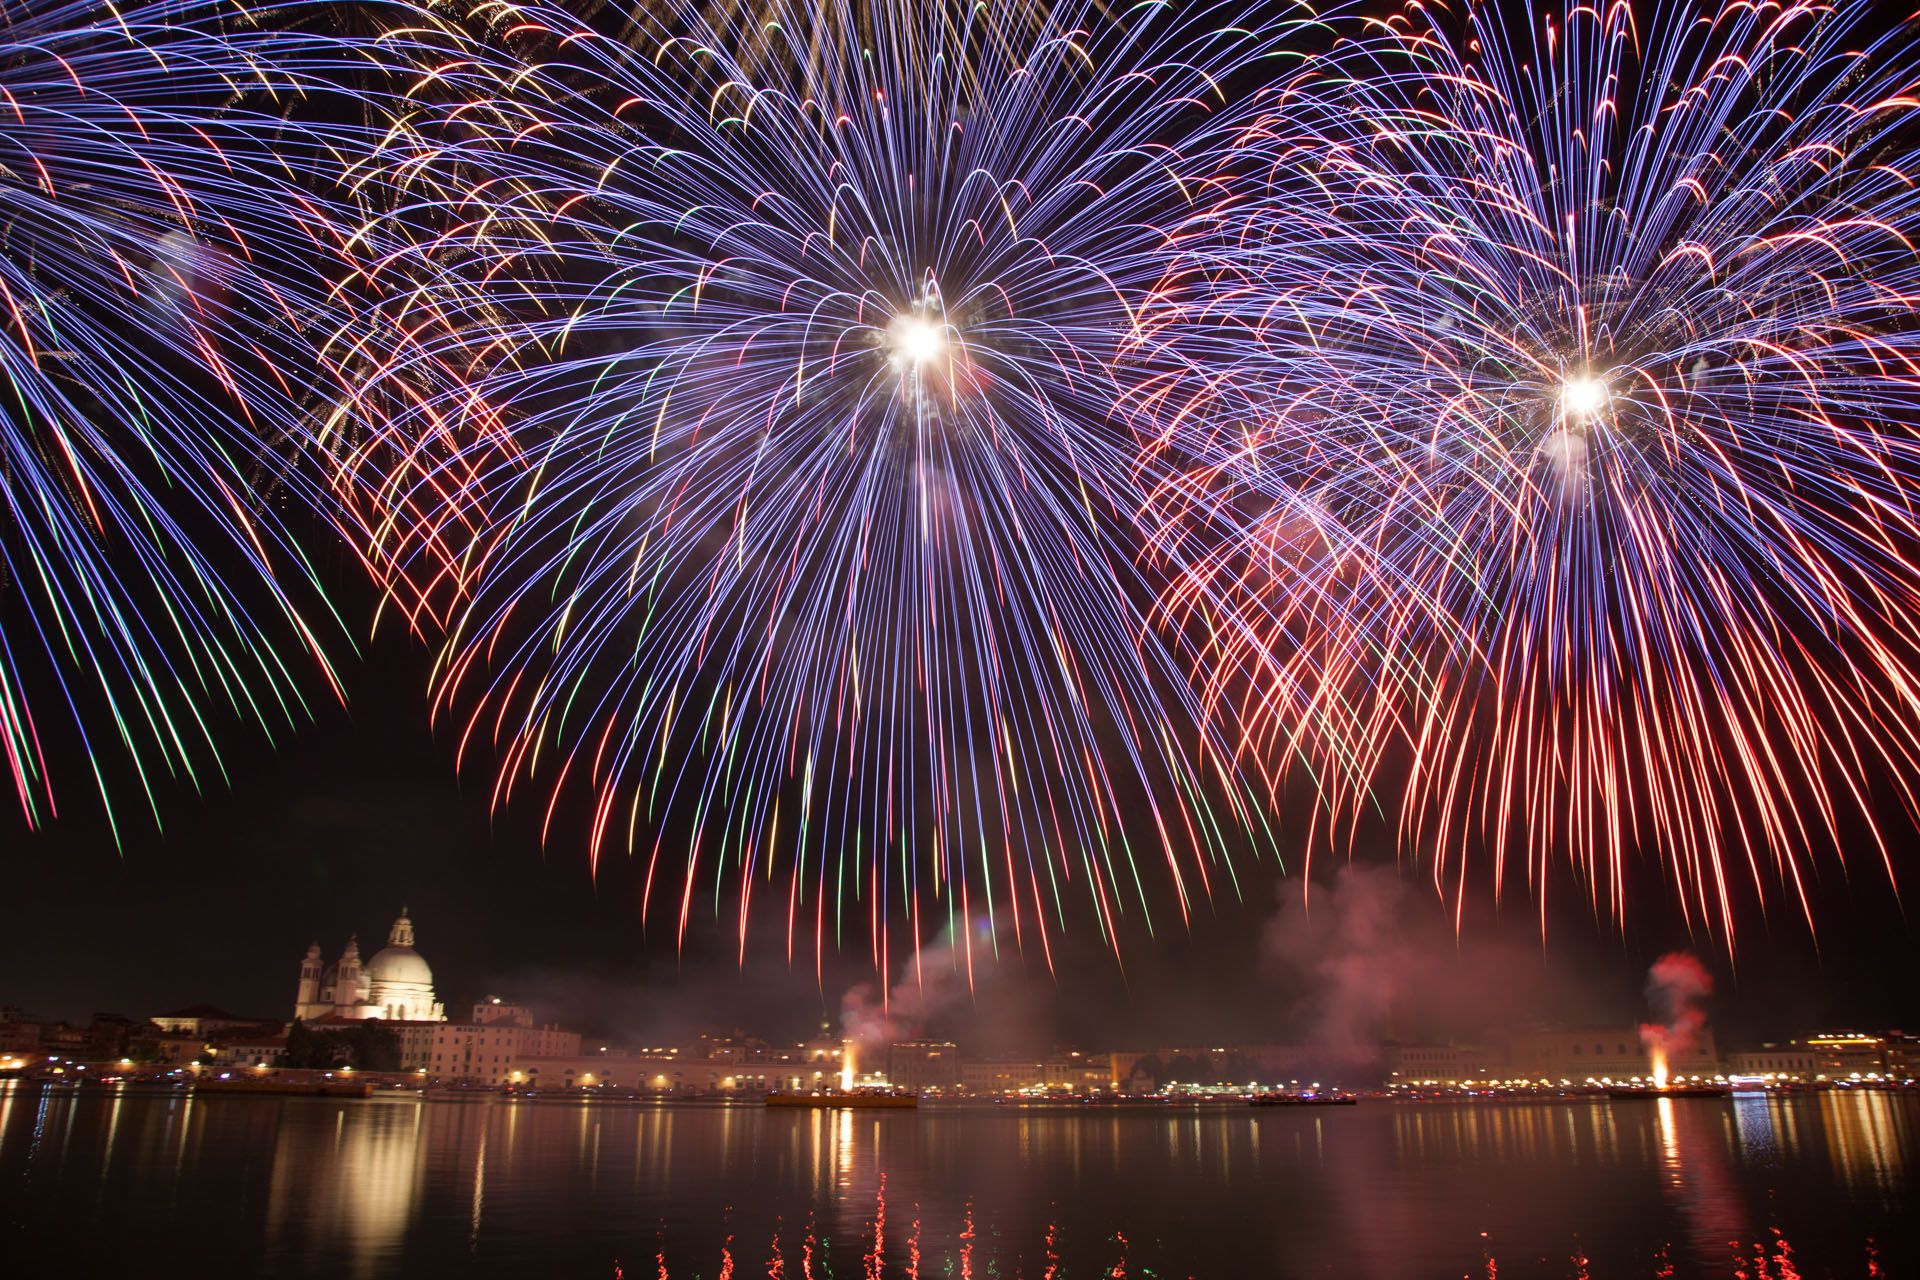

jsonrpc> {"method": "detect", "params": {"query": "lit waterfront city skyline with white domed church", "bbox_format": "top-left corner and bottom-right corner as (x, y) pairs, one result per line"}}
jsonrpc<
(0, 924), (1920, 1098)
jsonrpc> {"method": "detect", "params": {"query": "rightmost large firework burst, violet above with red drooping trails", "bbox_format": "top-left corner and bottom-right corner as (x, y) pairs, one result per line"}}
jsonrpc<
(1137, 2), (1920, 940)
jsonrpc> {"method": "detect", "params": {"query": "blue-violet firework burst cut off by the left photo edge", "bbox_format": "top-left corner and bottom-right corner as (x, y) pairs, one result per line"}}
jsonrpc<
(0, 4), (397, 831)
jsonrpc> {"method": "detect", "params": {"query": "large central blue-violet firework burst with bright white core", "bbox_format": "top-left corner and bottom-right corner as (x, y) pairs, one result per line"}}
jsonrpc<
(345, 4), (1344, 960)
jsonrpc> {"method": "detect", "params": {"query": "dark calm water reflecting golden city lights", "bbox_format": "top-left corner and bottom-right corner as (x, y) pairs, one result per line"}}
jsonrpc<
(0, 1082), (1920, 1280)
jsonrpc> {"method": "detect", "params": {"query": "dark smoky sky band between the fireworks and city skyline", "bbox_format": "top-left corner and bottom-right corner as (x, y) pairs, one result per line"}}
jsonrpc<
(0, 610), (1920, 1048)
